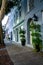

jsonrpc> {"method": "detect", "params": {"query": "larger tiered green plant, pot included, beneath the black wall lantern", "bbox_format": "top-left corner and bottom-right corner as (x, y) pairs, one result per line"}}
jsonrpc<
(30, 22), (42, 51)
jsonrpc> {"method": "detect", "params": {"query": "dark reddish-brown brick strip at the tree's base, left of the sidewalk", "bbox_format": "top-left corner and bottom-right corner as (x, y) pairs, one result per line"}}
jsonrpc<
(0, 45), (14, 65)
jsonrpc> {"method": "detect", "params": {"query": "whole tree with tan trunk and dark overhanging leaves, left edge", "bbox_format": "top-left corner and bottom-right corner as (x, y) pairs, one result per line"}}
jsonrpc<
(0, 0), (20, 44)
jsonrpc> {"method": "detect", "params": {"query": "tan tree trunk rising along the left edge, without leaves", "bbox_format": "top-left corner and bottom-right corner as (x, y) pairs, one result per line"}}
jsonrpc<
(0, 0), (7, 44)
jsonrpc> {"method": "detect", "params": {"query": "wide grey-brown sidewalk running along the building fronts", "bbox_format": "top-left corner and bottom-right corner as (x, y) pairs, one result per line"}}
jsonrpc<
(6, 45), (43, 65)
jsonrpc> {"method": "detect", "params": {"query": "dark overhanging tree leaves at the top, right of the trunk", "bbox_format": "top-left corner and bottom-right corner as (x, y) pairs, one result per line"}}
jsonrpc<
(5, 0), (21, 14)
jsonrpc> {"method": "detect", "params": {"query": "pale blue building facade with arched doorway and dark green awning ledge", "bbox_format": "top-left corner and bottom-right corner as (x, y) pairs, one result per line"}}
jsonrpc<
(4, 0), (43, 47)
